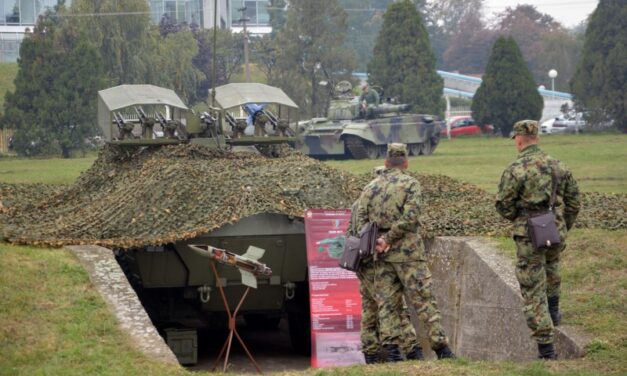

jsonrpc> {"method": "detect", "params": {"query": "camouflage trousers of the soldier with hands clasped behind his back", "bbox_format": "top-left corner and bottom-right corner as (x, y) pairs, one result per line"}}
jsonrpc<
(375, 261), (448, 350)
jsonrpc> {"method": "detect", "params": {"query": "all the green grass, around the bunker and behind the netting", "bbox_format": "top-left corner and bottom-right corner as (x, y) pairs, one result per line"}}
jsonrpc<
(0, 135), (627, 376)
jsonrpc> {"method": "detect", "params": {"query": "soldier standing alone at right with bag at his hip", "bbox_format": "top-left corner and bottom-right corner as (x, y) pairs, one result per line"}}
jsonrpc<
(496, 120), (580, 359)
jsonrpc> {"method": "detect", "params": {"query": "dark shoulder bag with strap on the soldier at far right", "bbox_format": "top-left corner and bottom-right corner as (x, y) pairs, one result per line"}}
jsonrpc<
(527, 165), (561, 250)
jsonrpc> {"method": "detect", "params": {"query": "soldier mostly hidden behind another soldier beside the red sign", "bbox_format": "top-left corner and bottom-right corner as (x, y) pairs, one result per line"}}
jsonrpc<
(346, 167), (418, 364)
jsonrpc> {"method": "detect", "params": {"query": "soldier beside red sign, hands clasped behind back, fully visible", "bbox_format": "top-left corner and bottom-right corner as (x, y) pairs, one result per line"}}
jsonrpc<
(357, 144), (455, 361)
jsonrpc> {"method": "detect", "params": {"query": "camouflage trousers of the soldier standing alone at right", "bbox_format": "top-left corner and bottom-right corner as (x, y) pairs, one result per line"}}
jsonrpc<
(514, 236), (566, 344)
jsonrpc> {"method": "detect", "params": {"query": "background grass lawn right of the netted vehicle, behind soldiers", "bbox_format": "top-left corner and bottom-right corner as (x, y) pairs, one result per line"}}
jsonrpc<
(329, 134), (627, 193)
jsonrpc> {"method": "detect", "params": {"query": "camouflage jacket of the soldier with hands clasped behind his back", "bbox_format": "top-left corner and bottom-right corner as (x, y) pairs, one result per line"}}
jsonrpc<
(357, 168), (425, 262)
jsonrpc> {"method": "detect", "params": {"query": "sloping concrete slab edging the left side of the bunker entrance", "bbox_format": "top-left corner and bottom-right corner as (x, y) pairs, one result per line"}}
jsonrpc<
(66, 245), (178, 364)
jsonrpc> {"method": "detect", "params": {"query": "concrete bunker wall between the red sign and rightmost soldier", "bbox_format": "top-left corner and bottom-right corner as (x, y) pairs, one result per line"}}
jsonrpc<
(424, 237), (585, 361)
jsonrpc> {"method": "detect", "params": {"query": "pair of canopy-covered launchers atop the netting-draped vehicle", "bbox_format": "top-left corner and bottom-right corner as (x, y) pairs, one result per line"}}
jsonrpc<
(98, 83), (298, 149)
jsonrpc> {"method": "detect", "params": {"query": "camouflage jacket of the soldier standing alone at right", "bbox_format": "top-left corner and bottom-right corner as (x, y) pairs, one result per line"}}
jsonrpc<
(496, 145), (581, 240)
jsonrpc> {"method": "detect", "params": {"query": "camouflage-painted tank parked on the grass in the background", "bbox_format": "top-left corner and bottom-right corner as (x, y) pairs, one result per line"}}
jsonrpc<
(297, 81), (444, 159)
